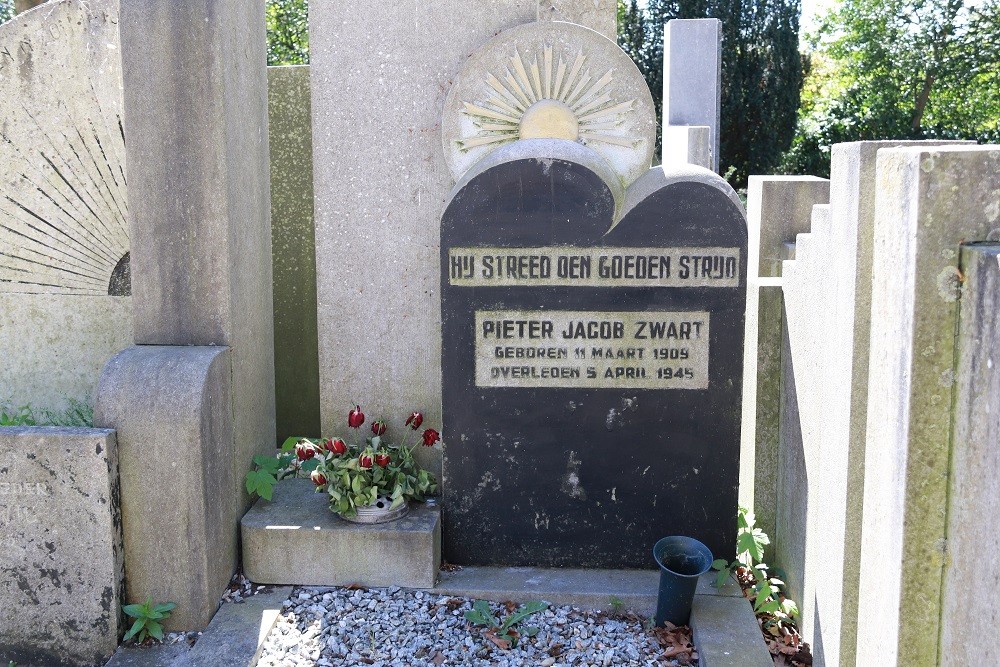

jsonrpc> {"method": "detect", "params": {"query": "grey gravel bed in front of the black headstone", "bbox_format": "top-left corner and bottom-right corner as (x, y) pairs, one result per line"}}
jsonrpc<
(258, 587), (688, 667)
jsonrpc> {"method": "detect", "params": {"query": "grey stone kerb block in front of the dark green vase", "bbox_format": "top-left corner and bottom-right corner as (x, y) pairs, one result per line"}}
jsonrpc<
(691, 595), (774, 667)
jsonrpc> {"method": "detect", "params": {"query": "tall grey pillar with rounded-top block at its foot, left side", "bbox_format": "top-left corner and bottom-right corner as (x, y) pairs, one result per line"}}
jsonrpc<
(95, 0), (275, 630)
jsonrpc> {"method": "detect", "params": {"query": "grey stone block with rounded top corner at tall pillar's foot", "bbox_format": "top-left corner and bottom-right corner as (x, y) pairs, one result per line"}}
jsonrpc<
(94, 346), (244, 630)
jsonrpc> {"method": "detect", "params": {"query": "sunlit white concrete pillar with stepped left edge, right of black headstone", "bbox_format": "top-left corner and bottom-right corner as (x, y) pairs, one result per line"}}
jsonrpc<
(775, 141), (968, 664)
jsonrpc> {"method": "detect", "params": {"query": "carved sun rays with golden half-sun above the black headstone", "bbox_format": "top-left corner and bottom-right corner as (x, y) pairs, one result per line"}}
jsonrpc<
(457, 46), (639, 151)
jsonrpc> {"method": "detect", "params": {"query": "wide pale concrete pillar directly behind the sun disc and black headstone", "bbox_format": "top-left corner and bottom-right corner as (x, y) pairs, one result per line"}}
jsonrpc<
(309, 0), (614, 472)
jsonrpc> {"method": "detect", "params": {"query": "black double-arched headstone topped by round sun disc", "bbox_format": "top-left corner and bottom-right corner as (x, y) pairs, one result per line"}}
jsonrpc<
(441, 22), (747, 568)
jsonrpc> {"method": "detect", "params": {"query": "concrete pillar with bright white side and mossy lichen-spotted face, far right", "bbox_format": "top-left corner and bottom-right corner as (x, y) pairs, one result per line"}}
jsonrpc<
(857, 146), (1000, 665)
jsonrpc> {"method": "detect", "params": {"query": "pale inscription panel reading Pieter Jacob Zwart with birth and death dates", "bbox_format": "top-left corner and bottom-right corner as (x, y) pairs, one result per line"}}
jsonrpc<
(475, 310), (709, 389)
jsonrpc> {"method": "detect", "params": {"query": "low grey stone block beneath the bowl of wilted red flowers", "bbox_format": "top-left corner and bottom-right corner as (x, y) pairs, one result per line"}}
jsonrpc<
(241, 479), (441, 588)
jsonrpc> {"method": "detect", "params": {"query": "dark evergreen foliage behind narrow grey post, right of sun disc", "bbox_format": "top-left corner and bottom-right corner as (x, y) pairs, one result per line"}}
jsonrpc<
(618, 0), (802, 186)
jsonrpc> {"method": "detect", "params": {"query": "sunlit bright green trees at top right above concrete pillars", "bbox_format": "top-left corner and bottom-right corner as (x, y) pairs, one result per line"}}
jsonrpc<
(782, 0), (1000, 175)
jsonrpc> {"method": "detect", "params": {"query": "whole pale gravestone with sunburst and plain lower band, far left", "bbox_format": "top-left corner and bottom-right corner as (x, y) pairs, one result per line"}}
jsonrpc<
(0, 0), (132, 418)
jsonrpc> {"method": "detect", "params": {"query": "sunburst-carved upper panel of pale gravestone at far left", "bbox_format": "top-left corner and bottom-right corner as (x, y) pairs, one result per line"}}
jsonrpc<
(0, 2), (131, 296)
